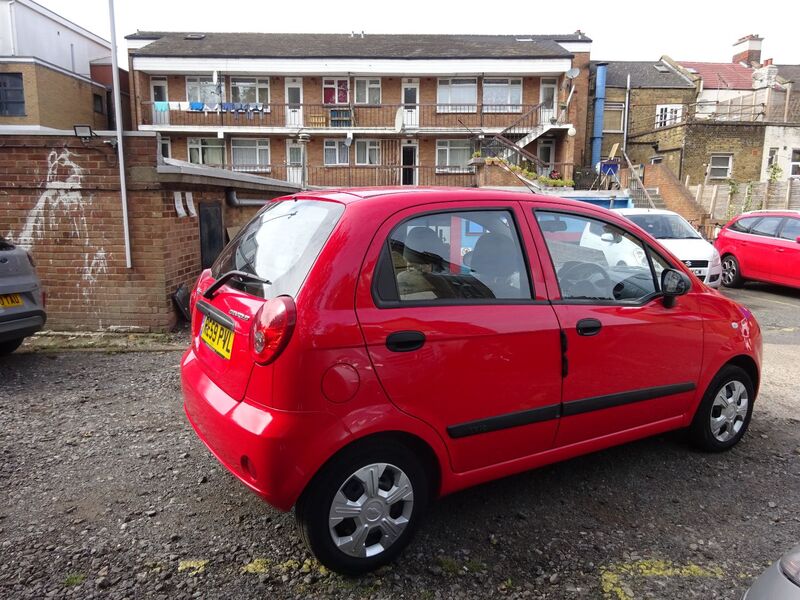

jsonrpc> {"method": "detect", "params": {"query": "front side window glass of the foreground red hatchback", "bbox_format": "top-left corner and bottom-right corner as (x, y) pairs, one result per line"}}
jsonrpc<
(535, 211), (656, 302)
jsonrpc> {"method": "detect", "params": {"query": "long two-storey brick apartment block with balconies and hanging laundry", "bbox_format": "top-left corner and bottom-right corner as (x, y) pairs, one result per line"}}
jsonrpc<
(127, 32), (591, 186)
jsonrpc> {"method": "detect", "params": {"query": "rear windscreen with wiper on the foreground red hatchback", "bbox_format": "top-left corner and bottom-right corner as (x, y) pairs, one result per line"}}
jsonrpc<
(211, 200), (344, 298)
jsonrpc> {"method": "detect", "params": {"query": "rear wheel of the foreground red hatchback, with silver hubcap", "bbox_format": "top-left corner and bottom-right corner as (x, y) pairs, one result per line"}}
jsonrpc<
(295, 440), (430, 575)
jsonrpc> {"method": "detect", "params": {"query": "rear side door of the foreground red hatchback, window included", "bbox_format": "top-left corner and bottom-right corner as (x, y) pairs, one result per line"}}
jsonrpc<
(356, 201), (561, 472)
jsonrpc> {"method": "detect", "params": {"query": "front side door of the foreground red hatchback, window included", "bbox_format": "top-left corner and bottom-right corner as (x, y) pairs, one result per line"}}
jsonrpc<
(528, 205), (703, 446)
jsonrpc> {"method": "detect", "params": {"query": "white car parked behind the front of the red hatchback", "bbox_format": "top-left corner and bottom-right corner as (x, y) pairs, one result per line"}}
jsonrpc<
(614, 208), (722, 288)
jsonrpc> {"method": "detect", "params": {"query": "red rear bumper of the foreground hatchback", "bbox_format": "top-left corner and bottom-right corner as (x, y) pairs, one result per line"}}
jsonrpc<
(181, 349), (343, 511)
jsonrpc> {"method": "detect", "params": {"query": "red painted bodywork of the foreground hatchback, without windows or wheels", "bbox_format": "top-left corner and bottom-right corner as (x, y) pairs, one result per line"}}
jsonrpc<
(181, 189), (761, 510)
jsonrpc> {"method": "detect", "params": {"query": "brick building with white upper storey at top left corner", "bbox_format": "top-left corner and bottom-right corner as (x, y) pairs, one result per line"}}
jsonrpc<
(0, 0), (130, 131)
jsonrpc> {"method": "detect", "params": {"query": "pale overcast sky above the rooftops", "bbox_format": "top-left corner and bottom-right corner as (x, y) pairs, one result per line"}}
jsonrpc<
(38, 0), (800, 64)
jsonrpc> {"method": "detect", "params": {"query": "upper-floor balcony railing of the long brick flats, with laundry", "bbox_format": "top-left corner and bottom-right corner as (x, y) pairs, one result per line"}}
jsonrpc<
(141, 102), (534, 130)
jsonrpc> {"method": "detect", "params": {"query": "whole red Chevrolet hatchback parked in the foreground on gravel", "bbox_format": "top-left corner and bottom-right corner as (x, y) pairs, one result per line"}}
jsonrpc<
(181, 188), (761, 574)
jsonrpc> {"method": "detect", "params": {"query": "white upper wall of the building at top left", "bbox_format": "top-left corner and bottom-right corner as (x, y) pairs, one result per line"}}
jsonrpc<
(0, 0), (111, 77)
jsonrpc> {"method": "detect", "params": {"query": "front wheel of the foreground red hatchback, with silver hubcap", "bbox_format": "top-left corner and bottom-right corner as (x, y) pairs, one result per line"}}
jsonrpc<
(689, 365), (756, 452)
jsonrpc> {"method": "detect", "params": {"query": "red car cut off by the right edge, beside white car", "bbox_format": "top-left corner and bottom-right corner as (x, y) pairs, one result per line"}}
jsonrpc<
(714, 210), (800, 288)
